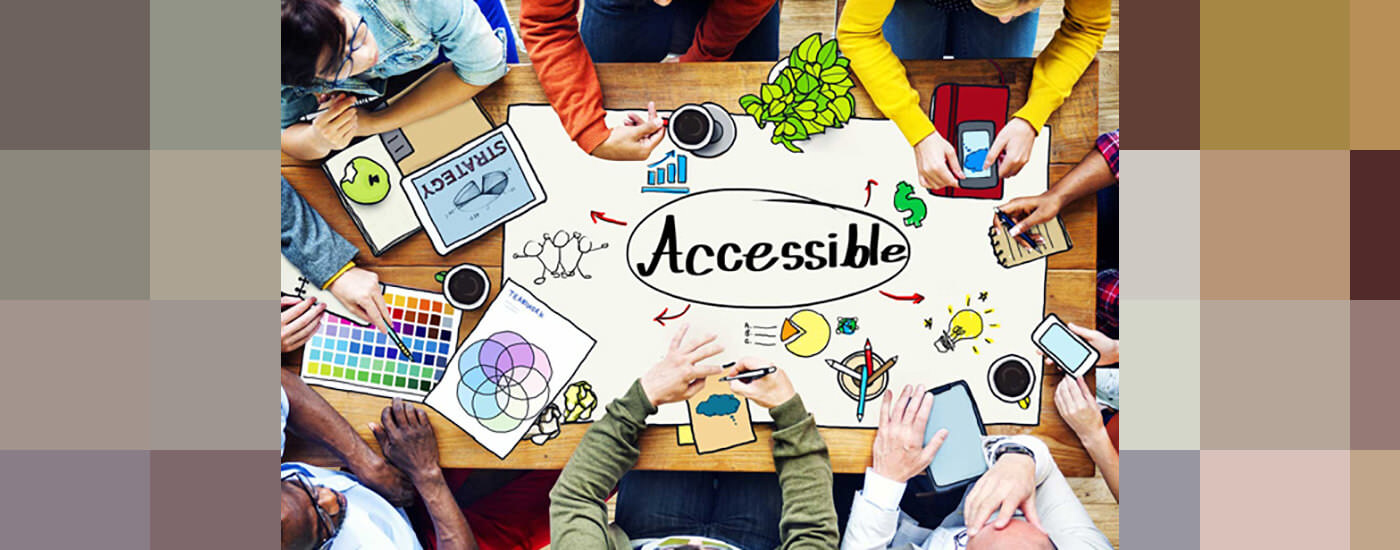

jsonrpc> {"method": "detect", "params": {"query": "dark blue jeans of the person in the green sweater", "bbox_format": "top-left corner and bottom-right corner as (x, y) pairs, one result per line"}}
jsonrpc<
(617, 470), (783, 550)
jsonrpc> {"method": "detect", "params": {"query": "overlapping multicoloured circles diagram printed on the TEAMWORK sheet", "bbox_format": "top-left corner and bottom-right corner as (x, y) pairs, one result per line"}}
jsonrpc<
(456, 330), (553, 434)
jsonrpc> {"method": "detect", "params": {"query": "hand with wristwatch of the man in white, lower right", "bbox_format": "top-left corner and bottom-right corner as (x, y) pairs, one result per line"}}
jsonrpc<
(963, 453), (1046, 536)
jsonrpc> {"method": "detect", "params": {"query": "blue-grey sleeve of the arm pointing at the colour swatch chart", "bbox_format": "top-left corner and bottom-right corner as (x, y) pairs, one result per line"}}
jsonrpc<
(281, 178), (360, 288)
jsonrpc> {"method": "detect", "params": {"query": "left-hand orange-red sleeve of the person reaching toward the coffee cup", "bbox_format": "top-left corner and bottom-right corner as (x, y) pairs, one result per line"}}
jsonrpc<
(521, 0), (609, 154)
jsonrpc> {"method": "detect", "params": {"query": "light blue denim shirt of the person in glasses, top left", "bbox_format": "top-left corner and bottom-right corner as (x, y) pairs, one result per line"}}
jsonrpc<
(281, 0), (507, 129)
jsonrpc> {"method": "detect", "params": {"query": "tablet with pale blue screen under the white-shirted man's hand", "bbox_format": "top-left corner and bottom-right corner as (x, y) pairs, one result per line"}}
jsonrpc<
(924, 381), (987, 491)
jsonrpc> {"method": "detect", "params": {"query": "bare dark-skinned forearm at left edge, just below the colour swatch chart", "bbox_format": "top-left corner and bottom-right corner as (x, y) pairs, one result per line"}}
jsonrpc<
(280, 368), (413, 507)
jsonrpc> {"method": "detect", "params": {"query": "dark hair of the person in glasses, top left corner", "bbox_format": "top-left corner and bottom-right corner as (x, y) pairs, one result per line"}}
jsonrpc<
(281, 0), (349, 85)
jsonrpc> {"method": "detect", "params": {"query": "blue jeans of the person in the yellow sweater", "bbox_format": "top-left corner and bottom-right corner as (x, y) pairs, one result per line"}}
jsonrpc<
(885, 0), (1040, 59)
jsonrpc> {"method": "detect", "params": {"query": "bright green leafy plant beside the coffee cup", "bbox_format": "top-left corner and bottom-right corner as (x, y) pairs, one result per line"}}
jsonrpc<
(739, 34), (855, 153)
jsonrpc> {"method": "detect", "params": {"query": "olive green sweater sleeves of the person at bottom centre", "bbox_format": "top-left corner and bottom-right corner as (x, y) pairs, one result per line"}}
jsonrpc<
(549, 382), (839, 550)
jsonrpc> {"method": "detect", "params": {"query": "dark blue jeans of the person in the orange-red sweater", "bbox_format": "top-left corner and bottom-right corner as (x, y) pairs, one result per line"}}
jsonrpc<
(578, 0), (781, 63)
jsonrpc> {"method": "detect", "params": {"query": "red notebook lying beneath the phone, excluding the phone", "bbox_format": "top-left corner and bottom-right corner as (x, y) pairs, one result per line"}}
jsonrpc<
(928, 84), (1011, 199)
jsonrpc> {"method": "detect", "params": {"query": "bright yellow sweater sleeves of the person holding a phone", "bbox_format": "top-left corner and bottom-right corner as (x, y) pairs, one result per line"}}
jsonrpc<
(836, 0), (1113, 146)
